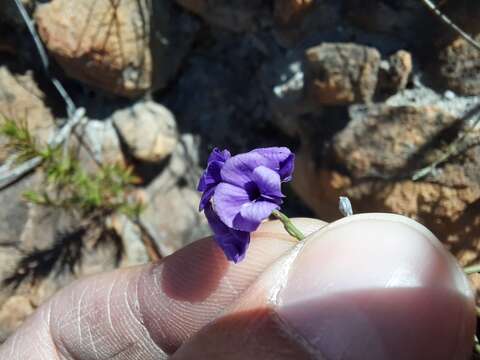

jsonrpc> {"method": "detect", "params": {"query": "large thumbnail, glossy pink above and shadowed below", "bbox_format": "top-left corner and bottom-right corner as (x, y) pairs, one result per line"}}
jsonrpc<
(277, 214), (475, 360)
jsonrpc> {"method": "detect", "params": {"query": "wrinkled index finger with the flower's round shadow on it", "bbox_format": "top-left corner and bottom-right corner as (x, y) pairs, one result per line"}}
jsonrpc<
(0, 219), (325, 359)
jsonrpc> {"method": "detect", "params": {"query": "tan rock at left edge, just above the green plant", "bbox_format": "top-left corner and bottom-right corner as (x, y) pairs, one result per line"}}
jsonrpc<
(0, 66), (54, 160)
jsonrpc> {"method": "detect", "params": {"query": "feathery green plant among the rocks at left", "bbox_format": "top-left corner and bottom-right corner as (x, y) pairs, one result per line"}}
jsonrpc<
(0, 119), (143, 219)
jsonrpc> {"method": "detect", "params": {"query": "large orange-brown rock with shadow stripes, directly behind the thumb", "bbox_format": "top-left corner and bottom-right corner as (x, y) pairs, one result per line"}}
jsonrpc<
(293, 105), (480, 276)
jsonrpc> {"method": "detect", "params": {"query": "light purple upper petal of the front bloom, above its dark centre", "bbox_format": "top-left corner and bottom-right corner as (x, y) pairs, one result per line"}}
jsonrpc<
(221, 151), (276, 187)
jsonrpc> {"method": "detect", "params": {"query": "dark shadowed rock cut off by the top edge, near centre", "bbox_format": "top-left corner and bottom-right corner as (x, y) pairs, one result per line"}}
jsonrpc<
(177, 0), (269, 32)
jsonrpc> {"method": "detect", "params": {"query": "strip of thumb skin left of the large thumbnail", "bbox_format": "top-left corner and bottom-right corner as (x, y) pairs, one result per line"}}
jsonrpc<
(171, 239), (316, 360)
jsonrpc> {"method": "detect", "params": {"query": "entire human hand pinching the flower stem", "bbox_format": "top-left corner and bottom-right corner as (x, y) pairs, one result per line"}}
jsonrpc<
(0, 215), (474, 360)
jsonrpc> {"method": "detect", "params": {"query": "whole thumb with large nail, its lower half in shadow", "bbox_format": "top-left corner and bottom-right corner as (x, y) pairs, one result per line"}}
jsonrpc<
(172, 214), (475, 360)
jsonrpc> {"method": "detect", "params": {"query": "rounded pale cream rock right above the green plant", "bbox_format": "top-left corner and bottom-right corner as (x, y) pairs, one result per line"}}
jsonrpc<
(112, 101), (178, 162)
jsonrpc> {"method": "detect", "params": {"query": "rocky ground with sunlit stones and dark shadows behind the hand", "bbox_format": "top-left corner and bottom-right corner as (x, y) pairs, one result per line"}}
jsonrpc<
(0, 0), (480, 339)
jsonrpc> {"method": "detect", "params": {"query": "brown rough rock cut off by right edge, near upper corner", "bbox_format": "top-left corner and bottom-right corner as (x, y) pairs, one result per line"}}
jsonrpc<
(438, 34), (480, 95)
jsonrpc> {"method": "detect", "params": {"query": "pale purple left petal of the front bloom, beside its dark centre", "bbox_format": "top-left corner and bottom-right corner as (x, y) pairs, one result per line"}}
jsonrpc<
(213, 183), (250, 230)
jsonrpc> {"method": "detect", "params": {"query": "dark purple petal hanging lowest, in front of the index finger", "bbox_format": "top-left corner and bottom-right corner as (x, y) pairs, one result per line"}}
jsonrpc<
(205, 205), (250, 263)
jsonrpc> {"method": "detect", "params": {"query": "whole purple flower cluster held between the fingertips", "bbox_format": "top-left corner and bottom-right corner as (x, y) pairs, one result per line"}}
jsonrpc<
(198, 147), (295, 262)
